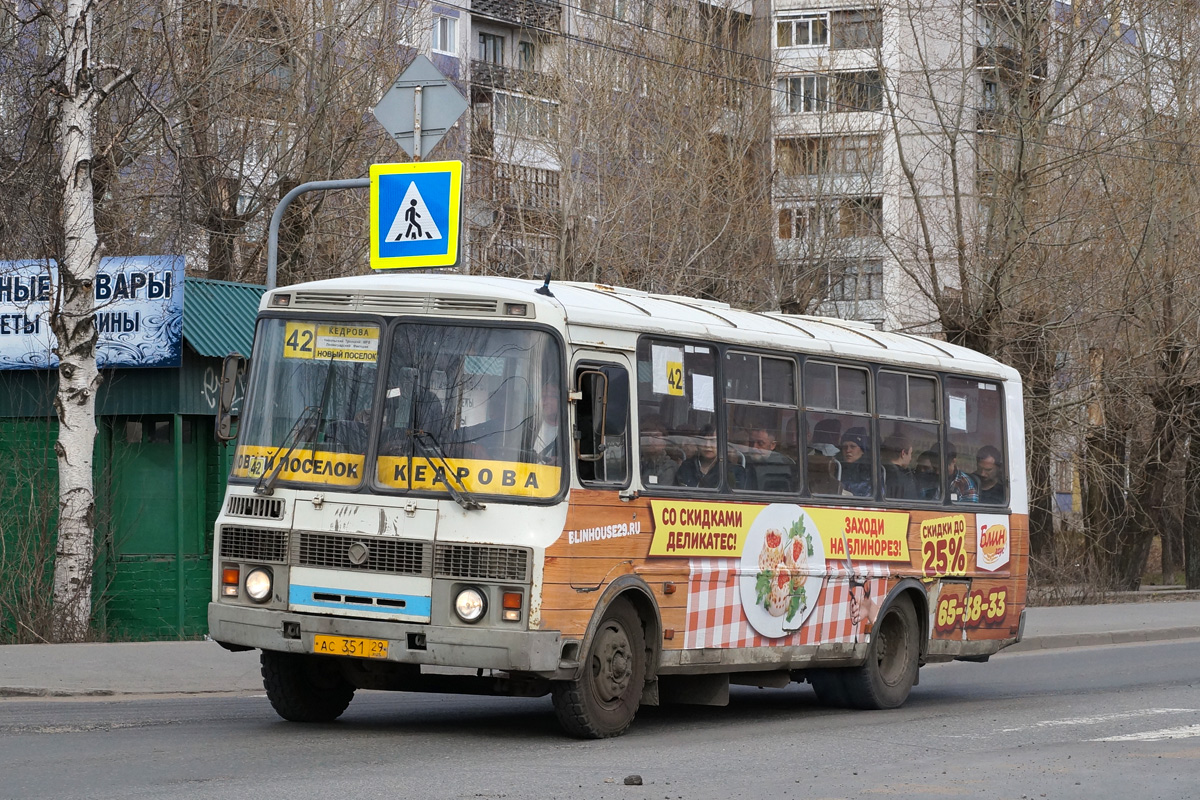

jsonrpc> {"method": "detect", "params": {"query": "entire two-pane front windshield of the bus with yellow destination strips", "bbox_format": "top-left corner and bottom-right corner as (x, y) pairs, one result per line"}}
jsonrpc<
(234, 319), (565, 498)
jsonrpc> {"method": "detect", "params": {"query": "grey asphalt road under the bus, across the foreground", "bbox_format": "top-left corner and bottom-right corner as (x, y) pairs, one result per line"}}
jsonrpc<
(0, 640), (1200, 800)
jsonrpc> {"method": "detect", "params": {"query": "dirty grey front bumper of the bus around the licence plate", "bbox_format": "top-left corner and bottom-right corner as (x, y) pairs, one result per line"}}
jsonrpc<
(209, 603), (562, 678)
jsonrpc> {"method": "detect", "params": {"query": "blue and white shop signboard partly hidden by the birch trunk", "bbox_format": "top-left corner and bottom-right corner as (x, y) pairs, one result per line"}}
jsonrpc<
(0, 255), (184, 369)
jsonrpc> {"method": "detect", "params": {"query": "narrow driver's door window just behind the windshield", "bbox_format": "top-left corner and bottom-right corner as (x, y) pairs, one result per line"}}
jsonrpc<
(575, 363), (629, 486)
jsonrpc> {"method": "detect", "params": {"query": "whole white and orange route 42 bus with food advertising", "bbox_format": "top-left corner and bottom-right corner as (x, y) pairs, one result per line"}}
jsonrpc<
(209, 275), (1028, 738)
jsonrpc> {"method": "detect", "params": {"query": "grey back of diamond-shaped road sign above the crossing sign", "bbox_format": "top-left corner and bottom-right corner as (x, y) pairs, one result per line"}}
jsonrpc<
(373, 55), (468, 156)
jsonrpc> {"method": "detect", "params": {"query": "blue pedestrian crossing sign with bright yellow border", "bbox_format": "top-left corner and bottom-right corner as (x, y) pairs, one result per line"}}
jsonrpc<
(371, 161), (462, 270)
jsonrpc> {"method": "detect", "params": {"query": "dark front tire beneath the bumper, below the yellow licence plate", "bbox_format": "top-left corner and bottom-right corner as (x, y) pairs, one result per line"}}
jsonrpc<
(260, 650), (354, 722)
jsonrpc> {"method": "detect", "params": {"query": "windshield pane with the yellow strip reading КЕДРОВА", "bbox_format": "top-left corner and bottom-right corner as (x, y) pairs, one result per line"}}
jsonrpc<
(376, 324), (564, 498)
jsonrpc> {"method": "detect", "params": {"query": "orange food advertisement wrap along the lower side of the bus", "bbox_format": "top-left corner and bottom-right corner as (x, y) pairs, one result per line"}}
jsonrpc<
(542, 492), (1027, 649)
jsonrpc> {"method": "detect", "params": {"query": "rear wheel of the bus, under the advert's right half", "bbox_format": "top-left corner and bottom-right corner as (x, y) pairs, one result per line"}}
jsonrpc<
(844, 595), (920, 710)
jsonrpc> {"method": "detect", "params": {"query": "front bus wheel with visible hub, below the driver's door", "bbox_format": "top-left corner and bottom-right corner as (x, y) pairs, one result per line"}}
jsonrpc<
(551, 599), (646, 739)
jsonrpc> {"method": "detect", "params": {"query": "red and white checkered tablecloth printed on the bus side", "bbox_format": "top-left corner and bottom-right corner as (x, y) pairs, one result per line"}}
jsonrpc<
(683, 558), (889, 649)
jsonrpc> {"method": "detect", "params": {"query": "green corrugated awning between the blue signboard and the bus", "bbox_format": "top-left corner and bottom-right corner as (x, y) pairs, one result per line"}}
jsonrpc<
(184, 278), (266, 359)
